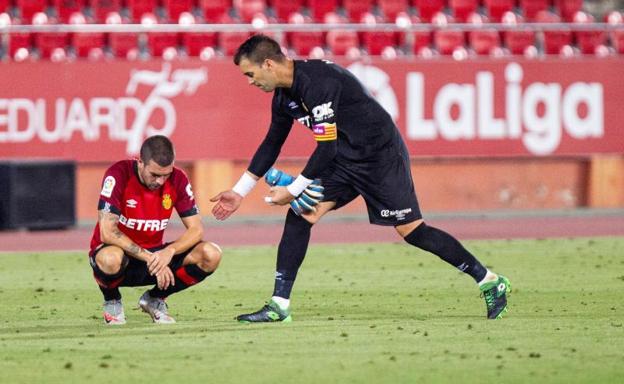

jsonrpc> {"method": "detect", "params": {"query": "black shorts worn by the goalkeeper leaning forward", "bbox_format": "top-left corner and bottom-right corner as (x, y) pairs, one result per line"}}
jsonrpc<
(321, 142), (422, 226)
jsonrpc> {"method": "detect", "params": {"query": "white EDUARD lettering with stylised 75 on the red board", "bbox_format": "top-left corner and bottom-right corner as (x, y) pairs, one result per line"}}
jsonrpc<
(0, 63), (208, 155)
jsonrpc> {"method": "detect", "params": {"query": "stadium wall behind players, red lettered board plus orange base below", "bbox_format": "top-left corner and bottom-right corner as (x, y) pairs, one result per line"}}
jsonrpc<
(0, 57), (624, 219)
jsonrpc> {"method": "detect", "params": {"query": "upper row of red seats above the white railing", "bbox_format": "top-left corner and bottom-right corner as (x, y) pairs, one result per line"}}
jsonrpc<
(0, 0), (583, 23)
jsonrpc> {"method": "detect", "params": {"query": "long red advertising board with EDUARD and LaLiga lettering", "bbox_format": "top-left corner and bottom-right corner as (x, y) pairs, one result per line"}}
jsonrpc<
(0, 58), (624, 162)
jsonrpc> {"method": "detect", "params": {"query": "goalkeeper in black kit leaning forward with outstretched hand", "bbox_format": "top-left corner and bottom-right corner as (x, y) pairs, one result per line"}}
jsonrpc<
(212, 35), (510, 322)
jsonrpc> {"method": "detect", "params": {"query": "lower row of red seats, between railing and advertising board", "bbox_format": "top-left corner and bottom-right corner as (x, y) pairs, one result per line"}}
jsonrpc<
(6, 23), (624, 60)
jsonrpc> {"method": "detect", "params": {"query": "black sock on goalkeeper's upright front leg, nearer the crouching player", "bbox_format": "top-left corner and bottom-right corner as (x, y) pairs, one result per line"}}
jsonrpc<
(273, 209), (312, 299)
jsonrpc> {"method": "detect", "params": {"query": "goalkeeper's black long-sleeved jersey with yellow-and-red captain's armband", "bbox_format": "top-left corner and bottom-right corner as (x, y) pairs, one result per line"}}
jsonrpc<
(249, 60), (401, 178)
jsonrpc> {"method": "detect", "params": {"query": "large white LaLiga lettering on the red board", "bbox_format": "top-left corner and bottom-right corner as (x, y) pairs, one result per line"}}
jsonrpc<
(406, 63), (604, 155)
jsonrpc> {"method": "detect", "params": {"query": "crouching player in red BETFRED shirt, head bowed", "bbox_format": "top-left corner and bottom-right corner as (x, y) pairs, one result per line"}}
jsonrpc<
(89, 136), (221, 325)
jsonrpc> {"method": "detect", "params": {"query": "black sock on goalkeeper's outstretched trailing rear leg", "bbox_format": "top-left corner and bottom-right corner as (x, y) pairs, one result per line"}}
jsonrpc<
(405, 223), (487, 282)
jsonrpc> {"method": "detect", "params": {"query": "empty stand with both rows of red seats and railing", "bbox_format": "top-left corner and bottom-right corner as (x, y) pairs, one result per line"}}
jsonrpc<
(0, 0), (624, 61)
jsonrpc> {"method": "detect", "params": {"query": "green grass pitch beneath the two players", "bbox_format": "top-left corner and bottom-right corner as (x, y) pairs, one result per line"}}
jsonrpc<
(0, 238), (624, 384)
